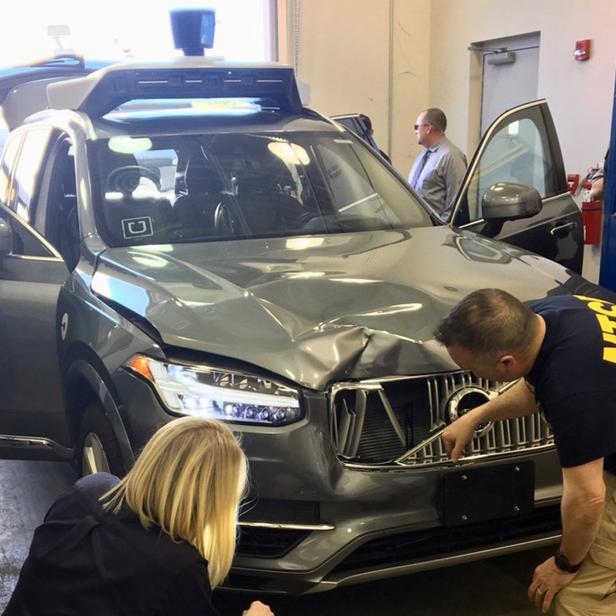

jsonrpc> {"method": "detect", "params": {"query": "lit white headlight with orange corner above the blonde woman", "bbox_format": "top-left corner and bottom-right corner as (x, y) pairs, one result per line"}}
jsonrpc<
(126, 355), (302, 426)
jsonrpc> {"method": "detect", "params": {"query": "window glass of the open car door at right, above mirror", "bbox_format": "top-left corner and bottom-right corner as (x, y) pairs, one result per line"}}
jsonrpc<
(456, 108), (558, 225)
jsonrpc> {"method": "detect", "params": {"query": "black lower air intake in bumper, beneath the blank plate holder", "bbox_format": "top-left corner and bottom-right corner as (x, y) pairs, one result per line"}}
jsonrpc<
(331, 505), (561, 573)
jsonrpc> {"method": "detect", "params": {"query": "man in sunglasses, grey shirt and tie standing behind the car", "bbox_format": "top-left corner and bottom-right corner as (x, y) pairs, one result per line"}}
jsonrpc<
(409, 107), (466, 219)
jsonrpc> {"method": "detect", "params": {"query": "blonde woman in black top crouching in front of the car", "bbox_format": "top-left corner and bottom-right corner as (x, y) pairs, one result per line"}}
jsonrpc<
(4, 417), (273, 616)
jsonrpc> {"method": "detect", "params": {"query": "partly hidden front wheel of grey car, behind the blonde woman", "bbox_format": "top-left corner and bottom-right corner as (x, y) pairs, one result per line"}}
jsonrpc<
(77, 402), (126, 477)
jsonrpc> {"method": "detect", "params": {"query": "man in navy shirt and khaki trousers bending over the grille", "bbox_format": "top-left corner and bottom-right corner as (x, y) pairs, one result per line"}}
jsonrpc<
(435, 289), (616, 616)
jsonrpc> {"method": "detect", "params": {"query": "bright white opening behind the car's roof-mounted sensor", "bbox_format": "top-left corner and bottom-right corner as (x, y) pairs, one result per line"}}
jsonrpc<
(0, 0), (276, 66)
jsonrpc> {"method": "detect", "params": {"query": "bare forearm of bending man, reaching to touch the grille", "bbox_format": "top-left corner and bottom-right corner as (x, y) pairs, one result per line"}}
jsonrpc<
(442, 380), (537, 462)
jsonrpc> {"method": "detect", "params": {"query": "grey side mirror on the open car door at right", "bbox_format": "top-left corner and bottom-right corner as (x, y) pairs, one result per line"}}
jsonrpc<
(481, 182), (543, 221)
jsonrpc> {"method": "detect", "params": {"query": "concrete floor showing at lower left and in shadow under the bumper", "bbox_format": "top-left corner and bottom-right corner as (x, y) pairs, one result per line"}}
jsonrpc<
(0, 460), (552, 616)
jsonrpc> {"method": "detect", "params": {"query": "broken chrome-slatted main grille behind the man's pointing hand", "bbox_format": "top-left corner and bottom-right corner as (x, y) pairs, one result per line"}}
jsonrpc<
(330, 372), (553, 466)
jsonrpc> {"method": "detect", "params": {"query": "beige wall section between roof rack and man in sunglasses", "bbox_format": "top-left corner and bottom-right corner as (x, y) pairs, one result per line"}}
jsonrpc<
(278, 0), (430, 174)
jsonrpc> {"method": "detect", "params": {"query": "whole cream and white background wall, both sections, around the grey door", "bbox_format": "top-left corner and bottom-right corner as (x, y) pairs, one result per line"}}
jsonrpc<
(284, 0), (616, 280)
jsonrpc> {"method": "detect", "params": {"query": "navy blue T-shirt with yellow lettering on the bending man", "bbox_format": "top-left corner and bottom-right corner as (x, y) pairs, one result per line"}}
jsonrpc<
(526, 295), (616, 474)
